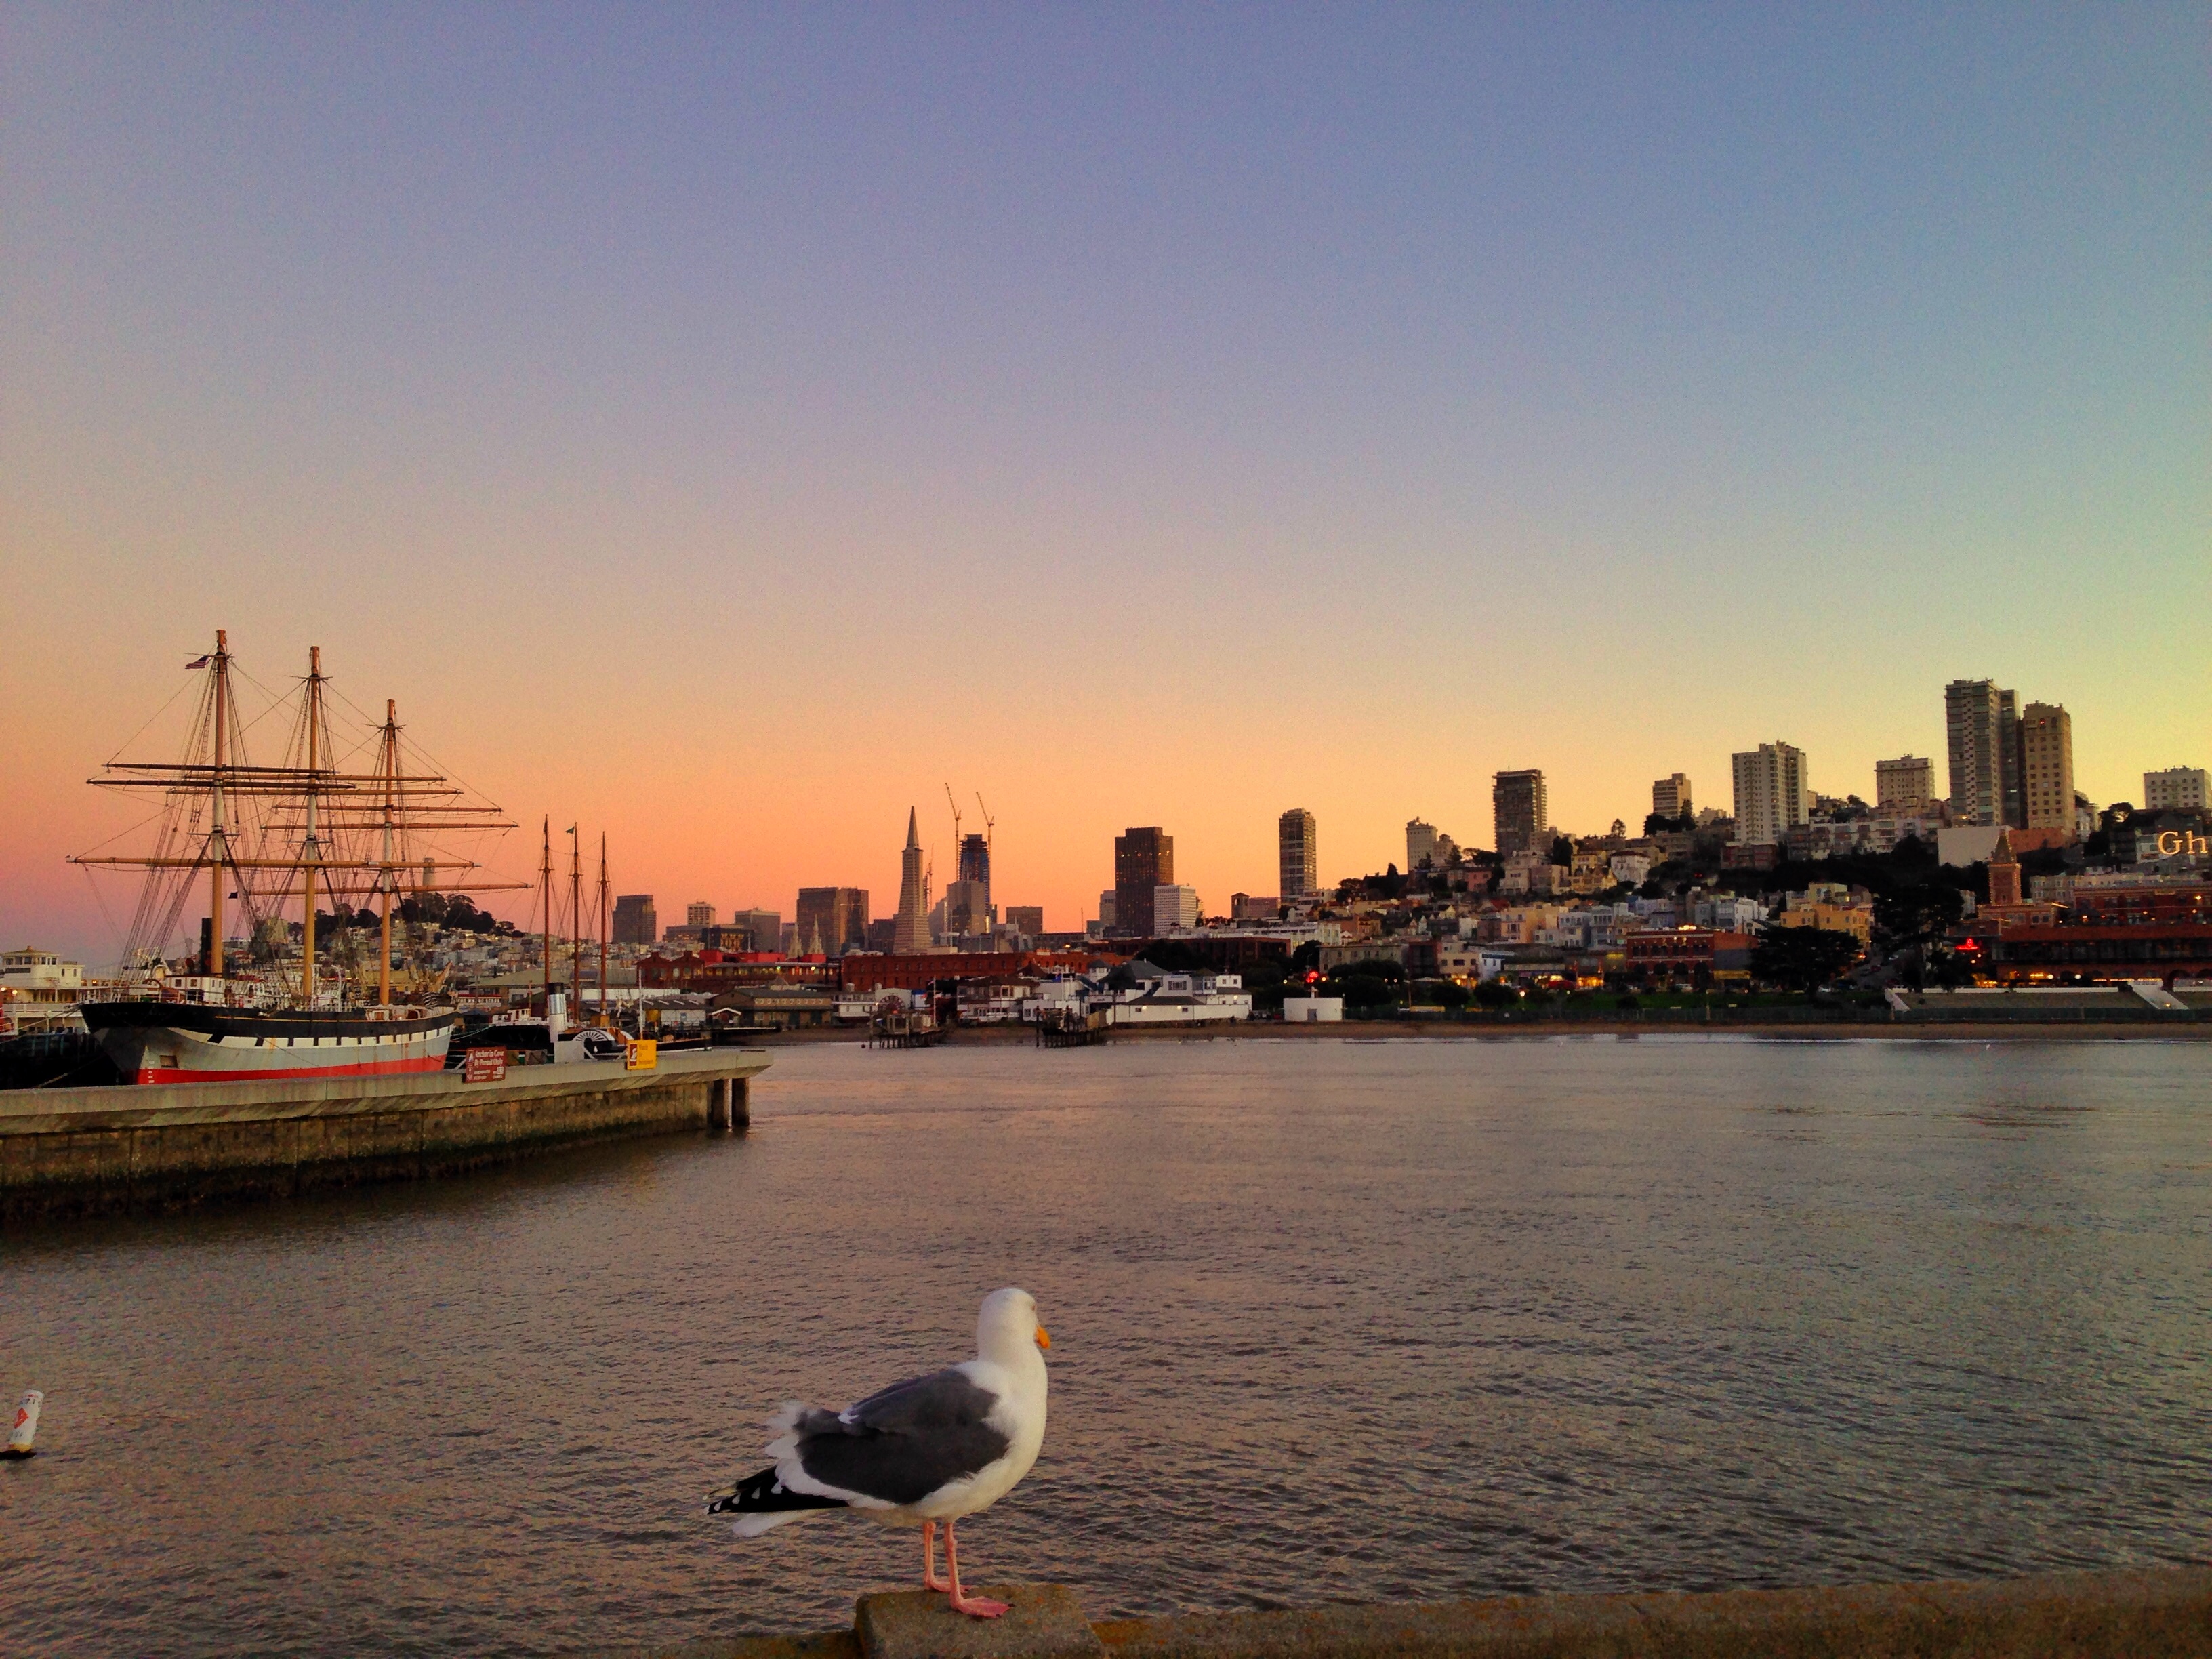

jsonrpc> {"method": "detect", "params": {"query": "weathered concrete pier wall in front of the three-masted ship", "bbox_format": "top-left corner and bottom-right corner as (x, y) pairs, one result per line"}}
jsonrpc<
(0, 1048), (768, 1221)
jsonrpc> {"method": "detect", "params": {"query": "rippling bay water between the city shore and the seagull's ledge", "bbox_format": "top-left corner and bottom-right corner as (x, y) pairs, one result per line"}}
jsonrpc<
(0, 1038), (2212, 1654)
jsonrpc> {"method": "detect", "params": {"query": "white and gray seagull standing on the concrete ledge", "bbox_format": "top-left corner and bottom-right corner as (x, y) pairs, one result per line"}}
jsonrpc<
(705, 1290), (1053, 1619)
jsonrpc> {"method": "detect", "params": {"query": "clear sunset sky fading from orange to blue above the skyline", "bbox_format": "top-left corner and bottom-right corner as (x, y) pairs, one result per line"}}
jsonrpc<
(0, 5), (2212, 962)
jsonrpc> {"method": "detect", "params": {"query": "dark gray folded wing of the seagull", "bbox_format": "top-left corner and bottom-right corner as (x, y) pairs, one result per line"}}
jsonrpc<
(794, 1369), (1011, 1504)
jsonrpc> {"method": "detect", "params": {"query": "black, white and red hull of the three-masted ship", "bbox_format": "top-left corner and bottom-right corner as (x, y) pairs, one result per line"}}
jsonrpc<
(82, 1002), (458, 1084)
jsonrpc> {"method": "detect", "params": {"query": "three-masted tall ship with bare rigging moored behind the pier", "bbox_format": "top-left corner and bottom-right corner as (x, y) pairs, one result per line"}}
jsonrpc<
(73, 630), (522, 1084)
